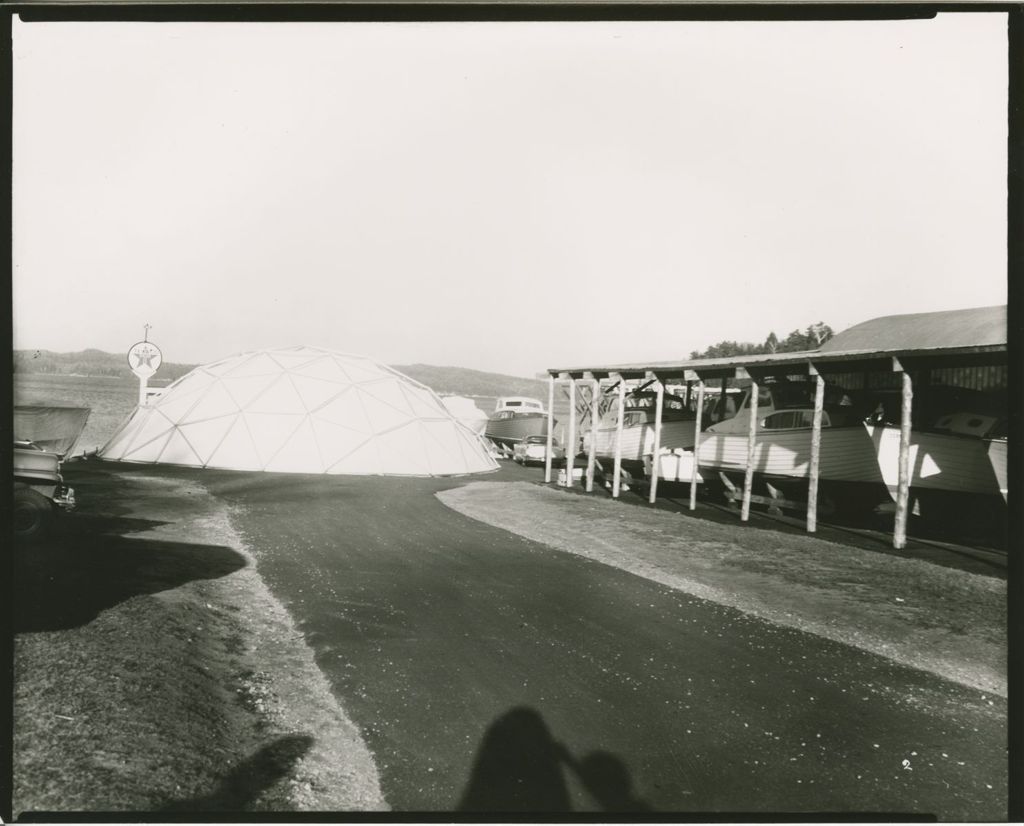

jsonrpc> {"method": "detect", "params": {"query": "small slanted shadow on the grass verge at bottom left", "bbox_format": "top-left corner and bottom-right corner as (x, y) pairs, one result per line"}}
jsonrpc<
(163, 734), (314, 813)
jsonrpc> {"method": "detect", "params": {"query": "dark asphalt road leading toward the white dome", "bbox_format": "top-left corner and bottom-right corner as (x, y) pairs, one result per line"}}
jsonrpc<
(202, 466), (1007, 821)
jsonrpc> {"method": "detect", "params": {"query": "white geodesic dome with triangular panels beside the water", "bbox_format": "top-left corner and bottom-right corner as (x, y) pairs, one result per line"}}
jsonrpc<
(99, 346), (498, 476)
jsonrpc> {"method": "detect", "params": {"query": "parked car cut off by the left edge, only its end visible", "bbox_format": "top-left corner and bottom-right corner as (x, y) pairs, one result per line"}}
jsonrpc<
(13, 441), (75, 539)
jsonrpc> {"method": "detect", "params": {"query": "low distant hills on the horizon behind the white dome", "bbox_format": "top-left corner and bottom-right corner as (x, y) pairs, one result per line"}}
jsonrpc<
(14, 349), (548, 398)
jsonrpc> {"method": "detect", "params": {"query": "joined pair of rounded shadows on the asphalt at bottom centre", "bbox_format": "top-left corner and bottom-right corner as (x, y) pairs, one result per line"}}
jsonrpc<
(458, 706), (651, 813)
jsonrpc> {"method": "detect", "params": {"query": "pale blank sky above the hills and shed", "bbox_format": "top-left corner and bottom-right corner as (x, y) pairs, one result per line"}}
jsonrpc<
(13, 13), (1008, 376)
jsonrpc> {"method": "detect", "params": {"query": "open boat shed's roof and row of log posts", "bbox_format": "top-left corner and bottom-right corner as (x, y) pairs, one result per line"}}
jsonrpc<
(545, 306), (1011, 549)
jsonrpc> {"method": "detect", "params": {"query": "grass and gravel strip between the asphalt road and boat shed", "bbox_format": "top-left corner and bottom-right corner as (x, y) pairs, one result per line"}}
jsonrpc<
(437, 482), (1007, 697)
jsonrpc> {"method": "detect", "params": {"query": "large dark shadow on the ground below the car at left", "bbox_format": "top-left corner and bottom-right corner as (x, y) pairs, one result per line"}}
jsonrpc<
(13, 517), (246, 634)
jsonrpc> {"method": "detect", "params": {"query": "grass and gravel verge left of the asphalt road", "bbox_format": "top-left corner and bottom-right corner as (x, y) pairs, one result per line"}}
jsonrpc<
(13, 466), (387, 817)
